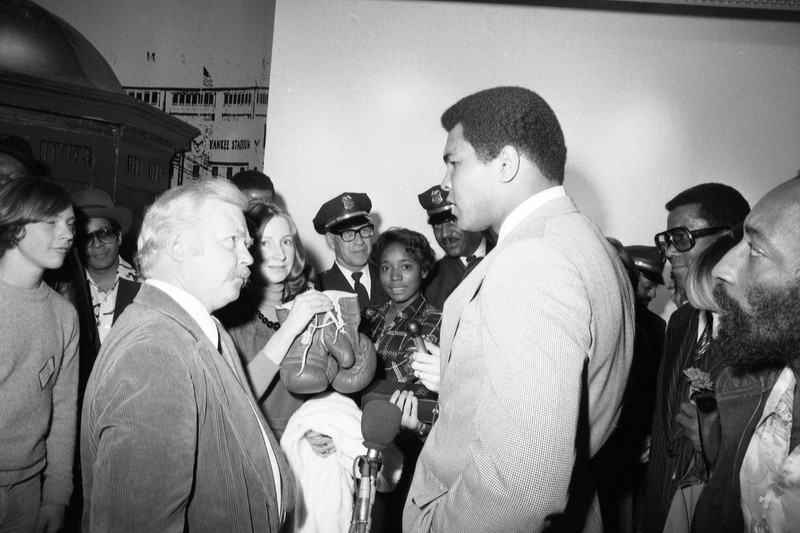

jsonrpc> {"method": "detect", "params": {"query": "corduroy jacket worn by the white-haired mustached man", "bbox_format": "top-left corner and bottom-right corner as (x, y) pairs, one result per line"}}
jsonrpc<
(81, 284), (294, 533)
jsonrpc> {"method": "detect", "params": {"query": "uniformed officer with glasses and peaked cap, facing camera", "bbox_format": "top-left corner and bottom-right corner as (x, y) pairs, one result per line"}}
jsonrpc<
(314, 192), (389, 310)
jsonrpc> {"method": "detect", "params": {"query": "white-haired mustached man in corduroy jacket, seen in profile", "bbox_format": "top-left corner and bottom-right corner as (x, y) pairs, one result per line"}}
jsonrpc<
(81, 180), (294, 533)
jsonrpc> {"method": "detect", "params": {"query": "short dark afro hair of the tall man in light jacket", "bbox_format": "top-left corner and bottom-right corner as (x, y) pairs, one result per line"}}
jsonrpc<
(442, 87), (567, 185)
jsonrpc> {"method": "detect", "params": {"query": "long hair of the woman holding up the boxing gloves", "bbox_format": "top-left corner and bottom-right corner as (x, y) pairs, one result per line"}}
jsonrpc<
(244, 202), (314, 302)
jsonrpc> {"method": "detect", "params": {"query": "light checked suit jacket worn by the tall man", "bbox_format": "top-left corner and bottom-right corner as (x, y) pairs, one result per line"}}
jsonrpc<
(403, 198), (635, 533)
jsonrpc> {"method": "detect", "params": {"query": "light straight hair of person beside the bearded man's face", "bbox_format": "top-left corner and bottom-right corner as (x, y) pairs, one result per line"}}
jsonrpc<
(686, 225), (742, 313)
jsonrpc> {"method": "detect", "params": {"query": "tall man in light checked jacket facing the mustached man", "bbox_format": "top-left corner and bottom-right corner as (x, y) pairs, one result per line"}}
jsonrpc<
(403, 87), (634, 533)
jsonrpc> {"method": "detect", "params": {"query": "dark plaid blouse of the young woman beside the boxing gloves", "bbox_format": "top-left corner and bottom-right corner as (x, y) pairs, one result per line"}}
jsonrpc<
(364, 295), (442, 381)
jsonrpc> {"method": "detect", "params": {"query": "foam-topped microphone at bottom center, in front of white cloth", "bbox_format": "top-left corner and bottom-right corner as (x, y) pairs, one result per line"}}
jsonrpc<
(350, 400), (403, 533)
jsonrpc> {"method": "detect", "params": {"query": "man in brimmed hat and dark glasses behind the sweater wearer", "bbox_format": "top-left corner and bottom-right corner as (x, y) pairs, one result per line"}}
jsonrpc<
(72, 189), (140, 343)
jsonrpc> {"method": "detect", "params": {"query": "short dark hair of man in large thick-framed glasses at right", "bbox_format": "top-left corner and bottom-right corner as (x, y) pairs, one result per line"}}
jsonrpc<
(664, 183), (750, 227)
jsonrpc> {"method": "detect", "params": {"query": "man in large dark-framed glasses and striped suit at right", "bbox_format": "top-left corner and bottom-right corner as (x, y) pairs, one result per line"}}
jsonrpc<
(639, 183), (750, 533)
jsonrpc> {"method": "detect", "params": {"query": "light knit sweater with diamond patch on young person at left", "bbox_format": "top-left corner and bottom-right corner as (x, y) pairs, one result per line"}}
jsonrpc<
(0, 280), (78, 505)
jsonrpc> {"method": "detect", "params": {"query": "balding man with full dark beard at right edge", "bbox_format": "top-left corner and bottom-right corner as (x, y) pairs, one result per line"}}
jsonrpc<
(693, 175), (800, 532)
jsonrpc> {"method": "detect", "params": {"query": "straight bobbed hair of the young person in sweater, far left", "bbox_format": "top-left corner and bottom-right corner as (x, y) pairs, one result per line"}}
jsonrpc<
(0, 178), (72, 257)
